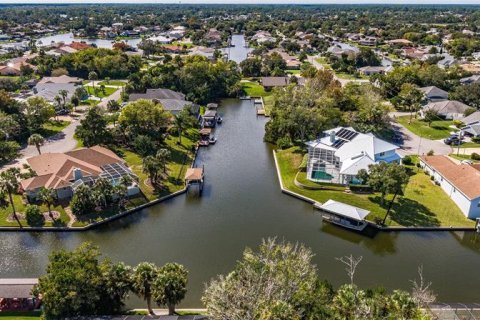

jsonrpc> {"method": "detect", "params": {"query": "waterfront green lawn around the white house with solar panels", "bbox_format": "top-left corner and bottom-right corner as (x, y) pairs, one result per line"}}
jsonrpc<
(277, 147), (475, 227)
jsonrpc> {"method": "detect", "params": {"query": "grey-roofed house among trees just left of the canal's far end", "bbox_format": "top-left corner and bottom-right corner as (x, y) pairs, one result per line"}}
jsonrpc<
(128, 89), (200, 115)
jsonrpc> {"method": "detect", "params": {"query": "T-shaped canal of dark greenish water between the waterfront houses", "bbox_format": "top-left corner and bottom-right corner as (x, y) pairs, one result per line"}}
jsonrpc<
(0, 35), (480, 307)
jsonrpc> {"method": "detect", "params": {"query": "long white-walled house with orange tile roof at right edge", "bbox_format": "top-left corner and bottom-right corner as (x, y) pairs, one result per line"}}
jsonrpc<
(420, 156), (480, 219)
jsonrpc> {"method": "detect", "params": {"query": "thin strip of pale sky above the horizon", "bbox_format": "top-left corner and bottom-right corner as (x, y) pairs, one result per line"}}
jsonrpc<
(0, 0), (480, 5)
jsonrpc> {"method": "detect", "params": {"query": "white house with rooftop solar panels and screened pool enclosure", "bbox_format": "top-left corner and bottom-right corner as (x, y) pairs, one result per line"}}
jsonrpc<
(307, 127), (401, 184)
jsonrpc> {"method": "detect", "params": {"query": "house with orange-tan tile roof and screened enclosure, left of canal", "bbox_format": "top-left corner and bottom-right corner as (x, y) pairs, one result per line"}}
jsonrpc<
(20, 146), (138, 200)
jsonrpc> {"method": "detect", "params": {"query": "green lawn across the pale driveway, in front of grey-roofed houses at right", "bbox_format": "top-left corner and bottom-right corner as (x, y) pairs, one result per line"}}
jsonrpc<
(396, 116), (455, 140)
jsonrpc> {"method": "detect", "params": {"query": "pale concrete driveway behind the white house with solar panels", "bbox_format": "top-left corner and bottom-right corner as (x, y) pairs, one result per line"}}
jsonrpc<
(391, 122), (452, 155)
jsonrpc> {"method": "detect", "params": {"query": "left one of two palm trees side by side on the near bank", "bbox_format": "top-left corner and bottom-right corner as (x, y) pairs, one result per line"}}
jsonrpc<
(132, 262), (158, 314)
